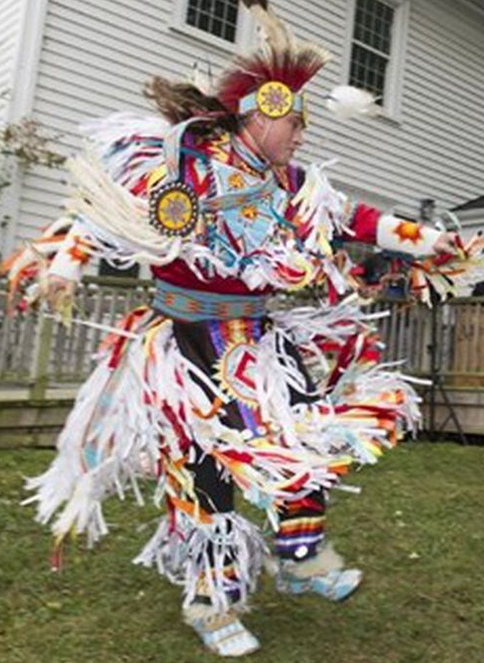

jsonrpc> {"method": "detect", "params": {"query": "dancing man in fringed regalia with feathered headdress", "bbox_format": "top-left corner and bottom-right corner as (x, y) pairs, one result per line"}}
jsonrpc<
(2, 2), (476, 656)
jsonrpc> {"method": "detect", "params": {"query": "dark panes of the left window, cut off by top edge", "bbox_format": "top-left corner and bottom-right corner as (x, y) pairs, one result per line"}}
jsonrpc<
(186, 0), (239, 43)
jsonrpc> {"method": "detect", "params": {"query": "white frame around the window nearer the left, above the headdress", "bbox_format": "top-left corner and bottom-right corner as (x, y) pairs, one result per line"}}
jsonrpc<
(170, 0), (255, 54)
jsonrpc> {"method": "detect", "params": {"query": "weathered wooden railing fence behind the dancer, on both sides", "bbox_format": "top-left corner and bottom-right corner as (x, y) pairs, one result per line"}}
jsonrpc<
(0, 277), (484, 400)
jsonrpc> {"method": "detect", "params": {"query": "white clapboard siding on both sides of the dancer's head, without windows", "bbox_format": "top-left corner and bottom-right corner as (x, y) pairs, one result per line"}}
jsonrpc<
(8, 0), (484, 245)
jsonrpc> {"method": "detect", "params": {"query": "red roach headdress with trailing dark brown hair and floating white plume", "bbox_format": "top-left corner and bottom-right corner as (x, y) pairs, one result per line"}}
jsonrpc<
(146, 0), (373, 129)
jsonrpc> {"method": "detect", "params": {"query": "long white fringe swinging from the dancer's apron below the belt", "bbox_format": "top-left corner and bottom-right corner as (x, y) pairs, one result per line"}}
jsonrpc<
(24, 304), (420, 544)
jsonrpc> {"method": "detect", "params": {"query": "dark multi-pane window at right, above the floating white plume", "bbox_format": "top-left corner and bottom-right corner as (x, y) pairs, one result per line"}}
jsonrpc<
(348, 0), (409, 115)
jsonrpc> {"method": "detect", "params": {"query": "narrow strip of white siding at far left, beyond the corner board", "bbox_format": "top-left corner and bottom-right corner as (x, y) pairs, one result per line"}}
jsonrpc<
(0, 0), (23, 122)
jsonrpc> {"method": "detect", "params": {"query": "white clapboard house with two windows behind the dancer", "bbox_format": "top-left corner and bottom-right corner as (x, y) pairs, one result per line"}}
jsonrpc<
(0, 0), (484, 264)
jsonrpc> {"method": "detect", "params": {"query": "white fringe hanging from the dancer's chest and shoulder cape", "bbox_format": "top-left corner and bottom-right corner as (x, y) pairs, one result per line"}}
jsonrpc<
(62, 149), (349, 293)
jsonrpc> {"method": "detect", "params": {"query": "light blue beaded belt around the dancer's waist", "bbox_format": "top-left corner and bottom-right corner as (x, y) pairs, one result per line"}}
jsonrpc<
(152, 279), (267, 322)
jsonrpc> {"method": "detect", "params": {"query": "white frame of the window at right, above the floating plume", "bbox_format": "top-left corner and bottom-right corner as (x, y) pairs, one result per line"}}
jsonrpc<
(342, 0), (410, 123)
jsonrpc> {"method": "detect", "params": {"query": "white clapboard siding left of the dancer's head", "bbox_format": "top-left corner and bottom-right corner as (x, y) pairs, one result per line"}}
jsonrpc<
(17, 0), (251, 240)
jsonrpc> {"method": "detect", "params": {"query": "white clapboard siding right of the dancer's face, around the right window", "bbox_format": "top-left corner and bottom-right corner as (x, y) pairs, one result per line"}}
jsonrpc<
(298, 0), (484, 215)
